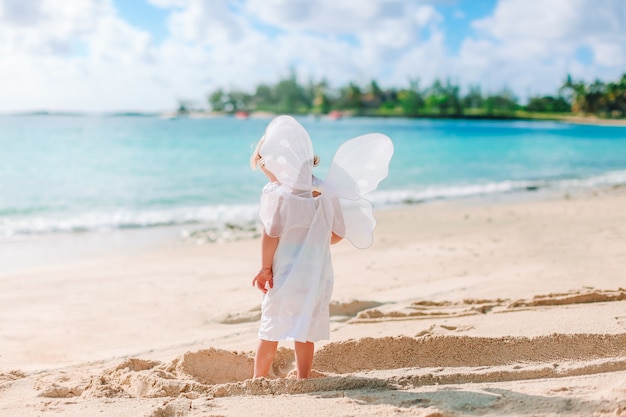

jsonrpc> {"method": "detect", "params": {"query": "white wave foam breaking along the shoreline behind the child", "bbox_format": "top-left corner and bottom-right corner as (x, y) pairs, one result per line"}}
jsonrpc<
(0, 170), (626, 238)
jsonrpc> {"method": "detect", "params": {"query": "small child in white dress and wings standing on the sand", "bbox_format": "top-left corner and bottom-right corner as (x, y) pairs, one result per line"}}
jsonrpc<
(250, 116), (393, 379)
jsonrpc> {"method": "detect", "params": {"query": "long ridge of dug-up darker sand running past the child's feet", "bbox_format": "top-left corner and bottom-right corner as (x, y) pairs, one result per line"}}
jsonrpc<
(37, 334), (626, 399)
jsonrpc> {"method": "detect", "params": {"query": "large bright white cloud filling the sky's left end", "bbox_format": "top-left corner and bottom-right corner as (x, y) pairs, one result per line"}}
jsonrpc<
(0, 0), (180, 111)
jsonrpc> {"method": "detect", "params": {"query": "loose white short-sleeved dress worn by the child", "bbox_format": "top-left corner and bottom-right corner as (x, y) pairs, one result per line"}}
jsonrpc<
(259, 179), (342, 342)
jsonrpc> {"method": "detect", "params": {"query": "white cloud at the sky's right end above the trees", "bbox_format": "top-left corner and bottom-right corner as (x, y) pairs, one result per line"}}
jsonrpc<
(453, 0), (626, 98)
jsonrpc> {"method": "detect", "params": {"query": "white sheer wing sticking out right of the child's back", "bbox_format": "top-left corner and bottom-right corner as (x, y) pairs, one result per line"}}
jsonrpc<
(324, 133), (393, 248)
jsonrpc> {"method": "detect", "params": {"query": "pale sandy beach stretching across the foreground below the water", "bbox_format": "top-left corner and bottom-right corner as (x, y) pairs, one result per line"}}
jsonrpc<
(0, 187), (626, 417)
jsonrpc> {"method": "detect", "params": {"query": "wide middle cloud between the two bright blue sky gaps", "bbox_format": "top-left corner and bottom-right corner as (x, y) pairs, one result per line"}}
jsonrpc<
(141, 0), (441, 94)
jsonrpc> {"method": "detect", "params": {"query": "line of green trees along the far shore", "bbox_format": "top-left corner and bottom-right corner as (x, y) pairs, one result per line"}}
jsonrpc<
(208, 71), (626, 118)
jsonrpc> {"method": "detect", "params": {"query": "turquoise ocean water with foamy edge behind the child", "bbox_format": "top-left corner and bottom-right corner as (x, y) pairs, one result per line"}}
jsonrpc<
(0, 115), (626, 239)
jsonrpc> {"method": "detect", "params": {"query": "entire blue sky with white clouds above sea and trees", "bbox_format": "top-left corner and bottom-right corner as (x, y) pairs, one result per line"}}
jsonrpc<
(0, 0), (626, 112)
